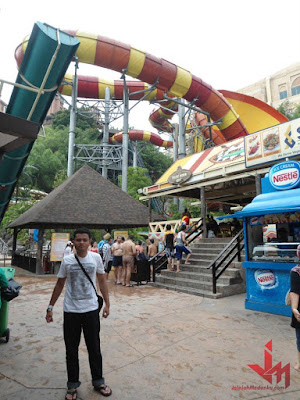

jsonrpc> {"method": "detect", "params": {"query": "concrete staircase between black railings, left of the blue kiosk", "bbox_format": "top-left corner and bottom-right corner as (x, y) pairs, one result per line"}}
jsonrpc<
(155, 238), (246, 298)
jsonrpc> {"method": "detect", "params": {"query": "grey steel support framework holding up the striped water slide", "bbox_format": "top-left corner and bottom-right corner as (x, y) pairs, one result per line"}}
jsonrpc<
(64, 63), (218, 191)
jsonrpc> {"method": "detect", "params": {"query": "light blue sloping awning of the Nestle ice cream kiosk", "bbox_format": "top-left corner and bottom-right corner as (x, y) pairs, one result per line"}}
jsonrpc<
(226, 188), (300, 218)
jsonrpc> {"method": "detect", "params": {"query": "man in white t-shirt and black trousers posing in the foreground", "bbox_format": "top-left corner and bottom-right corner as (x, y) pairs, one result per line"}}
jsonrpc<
(46, 228), (112, 400)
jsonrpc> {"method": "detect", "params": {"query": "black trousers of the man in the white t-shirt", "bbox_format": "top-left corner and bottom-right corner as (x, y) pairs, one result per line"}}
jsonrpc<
(64, 310), (104, 389)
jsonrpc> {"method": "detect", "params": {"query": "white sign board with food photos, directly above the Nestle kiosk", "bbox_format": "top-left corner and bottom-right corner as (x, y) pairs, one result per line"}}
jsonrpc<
(244, 118), (300, 167)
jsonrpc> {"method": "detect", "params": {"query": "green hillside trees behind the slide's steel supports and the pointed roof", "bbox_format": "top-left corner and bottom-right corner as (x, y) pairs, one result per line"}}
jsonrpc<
(20, 108), (172, 198)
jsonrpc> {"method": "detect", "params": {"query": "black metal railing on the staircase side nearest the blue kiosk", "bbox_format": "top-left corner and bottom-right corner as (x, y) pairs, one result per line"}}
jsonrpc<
(207, 230), (244, 293)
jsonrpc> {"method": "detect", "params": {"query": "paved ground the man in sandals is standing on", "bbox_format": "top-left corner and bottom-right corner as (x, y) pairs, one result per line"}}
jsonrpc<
(0, 270), (300, 400)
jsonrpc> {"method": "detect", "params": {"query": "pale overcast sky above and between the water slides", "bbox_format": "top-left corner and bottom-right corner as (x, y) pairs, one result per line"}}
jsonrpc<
(0, 0), (300, 130)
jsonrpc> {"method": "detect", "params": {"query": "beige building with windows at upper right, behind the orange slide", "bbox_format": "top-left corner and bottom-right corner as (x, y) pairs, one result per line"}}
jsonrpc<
(238, 62), (300, 108)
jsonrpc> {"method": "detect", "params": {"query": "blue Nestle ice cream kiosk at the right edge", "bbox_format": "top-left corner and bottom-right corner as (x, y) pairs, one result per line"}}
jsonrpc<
(234, 161), (300, 316)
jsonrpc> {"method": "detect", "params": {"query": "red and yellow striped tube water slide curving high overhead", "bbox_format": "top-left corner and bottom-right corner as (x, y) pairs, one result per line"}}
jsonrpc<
(15, 31), (287, 150)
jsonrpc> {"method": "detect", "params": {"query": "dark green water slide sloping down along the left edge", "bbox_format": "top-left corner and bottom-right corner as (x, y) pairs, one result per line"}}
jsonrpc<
(0, 22), (79, 221)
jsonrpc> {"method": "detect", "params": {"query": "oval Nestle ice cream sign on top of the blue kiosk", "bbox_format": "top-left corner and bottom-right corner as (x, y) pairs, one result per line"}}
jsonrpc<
(269, 161), (300, 190)
